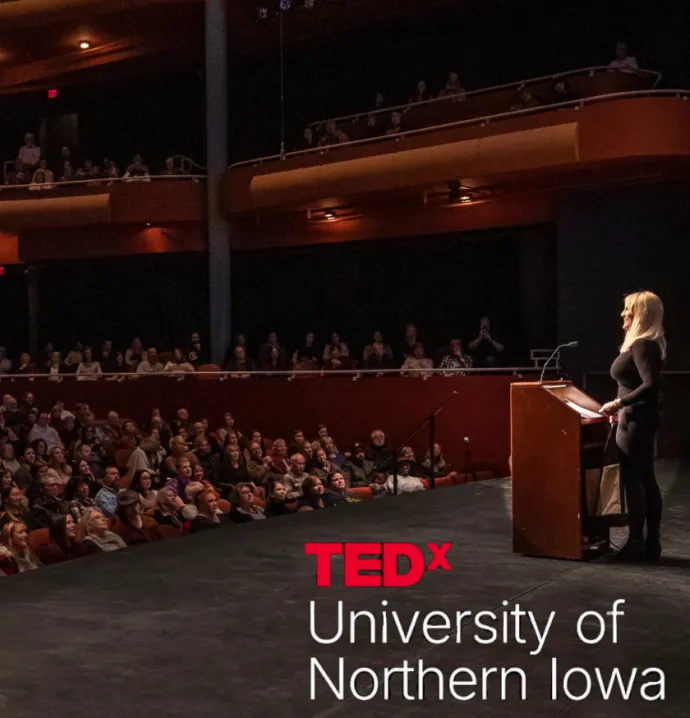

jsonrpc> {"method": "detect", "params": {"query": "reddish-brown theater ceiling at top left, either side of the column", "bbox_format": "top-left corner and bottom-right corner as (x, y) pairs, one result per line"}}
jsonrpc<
(0, 0), (463, 94)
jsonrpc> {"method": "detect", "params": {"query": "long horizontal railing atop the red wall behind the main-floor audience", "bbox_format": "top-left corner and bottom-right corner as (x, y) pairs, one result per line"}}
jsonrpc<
(0, 366), (540, 383)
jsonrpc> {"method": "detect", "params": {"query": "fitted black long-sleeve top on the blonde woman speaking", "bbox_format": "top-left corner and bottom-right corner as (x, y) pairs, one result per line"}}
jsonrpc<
(611, 339), (664, 409)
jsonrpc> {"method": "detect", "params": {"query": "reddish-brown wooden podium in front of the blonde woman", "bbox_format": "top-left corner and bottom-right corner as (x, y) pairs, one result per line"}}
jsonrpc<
(510, 381), (611, 560)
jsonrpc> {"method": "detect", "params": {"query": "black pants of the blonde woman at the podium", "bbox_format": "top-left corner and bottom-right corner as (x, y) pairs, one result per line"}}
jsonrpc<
(616, 407), (662, 541)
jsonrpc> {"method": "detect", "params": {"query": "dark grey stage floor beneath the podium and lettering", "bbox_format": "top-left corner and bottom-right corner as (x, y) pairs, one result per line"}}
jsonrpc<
(0, 461), (690, 718)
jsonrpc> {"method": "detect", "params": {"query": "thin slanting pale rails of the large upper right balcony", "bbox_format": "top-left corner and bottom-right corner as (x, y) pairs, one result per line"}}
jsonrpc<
(230, 70), (676, 169)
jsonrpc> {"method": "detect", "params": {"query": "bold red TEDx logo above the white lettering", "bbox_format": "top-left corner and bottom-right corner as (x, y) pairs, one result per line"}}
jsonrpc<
(304, 543), (453, 588)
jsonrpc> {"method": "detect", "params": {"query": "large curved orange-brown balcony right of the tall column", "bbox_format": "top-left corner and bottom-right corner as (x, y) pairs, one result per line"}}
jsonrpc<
(221, 68), (690, 248)
